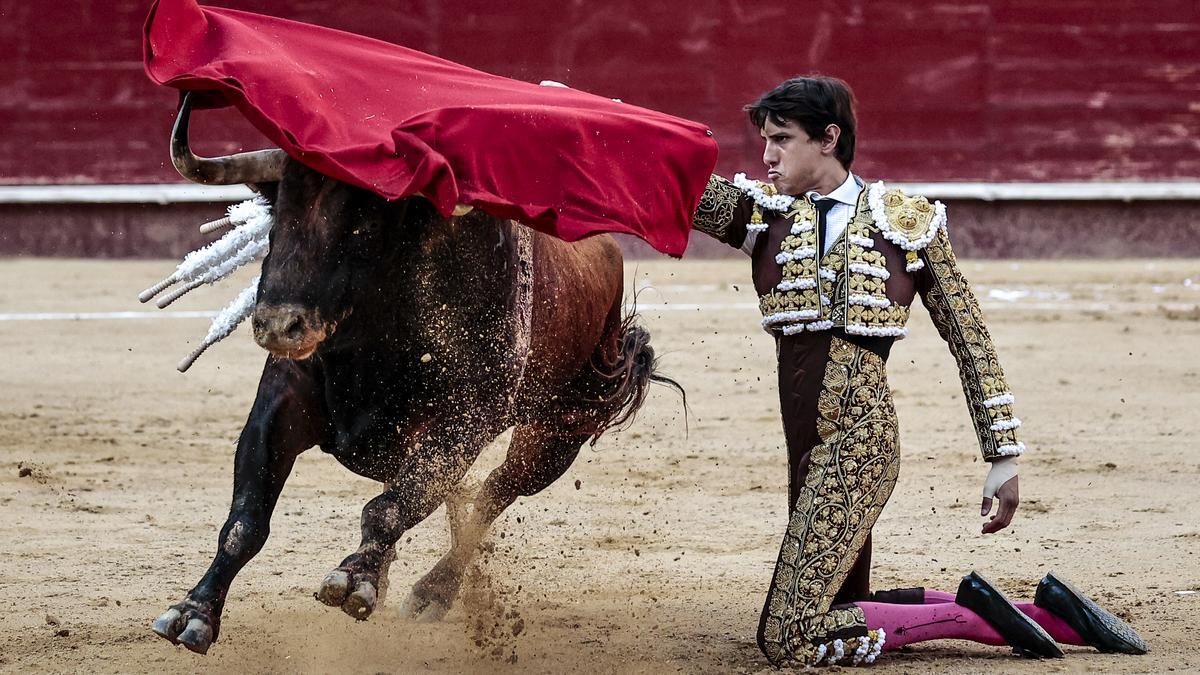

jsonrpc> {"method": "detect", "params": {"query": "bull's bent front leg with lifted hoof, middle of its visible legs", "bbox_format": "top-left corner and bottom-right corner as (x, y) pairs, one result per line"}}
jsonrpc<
(317, 418), (497, 621)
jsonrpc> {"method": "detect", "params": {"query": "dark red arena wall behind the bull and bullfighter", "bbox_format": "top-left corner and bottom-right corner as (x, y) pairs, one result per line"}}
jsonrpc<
(0, 0), (1200, 255)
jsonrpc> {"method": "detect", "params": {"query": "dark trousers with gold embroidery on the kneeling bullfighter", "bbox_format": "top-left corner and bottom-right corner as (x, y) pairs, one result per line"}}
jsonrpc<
(758, 333), (900, 665)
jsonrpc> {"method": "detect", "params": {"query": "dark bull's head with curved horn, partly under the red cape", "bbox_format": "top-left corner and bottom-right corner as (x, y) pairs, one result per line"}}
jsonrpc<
(172, 96), (409, 359)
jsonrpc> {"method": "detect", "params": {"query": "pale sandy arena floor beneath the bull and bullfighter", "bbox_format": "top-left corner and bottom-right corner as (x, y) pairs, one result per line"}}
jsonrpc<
(0, 254), (1200, 673)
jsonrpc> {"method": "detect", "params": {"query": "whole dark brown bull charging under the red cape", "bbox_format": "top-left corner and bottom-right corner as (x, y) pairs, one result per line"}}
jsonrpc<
(152, 98), (682, 653)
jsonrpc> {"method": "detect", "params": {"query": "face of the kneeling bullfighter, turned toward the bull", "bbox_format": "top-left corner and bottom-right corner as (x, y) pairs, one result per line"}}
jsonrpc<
(760, 118), (840, 196)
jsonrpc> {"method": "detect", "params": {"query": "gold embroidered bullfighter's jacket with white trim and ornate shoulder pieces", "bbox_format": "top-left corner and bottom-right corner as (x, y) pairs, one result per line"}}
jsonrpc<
(695, 174), (1025, 460)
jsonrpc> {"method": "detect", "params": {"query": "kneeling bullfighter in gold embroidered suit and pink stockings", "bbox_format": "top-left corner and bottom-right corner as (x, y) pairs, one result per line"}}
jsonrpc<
(695, 77), (1147, 665)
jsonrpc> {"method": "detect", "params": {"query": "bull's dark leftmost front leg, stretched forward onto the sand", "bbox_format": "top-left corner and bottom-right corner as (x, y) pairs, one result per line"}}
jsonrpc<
(152, 357), (328, 653)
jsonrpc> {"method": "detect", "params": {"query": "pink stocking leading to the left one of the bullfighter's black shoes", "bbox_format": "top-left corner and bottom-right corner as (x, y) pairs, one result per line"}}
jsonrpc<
(854, 602), (1008, 651)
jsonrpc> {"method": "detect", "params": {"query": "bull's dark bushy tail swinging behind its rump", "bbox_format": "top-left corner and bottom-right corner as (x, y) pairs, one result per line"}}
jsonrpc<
(590, 312), (688, 446)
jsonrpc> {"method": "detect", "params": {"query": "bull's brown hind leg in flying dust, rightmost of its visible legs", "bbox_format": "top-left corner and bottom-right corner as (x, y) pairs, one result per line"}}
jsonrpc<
(401, 425), (588, 621)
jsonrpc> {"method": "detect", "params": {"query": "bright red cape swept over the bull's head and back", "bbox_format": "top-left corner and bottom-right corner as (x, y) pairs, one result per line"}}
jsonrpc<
(144, 0), (716, 256)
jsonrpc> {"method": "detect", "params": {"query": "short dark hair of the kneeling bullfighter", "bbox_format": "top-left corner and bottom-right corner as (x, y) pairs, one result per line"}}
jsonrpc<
(745, 76), (857, 169)
